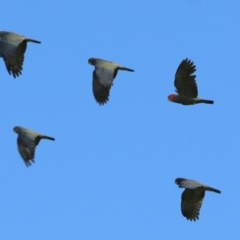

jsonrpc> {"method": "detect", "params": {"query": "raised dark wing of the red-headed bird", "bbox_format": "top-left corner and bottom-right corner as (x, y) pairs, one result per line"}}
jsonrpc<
(174, 58), (198, 98)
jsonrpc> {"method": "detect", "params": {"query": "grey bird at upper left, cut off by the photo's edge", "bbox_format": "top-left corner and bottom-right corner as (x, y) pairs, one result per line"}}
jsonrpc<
(0, 31), (41, 78)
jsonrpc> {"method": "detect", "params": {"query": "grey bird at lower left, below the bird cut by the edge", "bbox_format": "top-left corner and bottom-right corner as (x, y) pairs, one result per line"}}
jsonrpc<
(13, 126), (55, 167)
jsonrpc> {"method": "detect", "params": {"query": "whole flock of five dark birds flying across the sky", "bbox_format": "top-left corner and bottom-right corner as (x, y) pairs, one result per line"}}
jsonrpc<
(0, 31), (221, 221)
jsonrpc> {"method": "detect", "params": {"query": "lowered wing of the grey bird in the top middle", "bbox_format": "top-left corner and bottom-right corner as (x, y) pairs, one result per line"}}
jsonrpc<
(93, 64), (117, 104)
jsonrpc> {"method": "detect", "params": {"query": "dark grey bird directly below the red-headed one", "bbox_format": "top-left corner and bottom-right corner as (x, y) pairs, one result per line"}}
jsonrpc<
(175, 178), (221, 221)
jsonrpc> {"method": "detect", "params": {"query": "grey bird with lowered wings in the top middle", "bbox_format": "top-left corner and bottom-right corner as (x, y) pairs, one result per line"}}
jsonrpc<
(88, 58), (134, 105)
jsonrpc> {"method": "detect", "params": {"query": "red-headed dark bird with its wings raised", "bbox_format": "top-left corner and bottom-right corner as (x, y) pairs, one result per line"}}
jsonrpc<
(168, 58), (214, 105)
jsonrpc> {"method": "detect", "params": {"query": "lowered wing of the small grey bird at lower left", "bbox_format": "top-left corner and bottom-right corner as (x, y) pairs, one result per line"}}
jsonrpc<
(17, 135), (36, 166)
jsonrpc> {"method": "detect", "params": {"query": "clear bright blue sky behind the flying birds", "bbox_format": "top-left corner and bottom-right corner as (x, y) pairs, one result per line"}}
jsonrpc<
(0, 0), (240, 240)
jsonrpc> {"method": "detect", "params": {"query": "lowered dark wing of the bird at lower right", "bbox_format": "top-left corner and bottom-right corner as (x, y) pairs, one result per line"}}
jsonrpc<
(181, 187), (205, 221)
